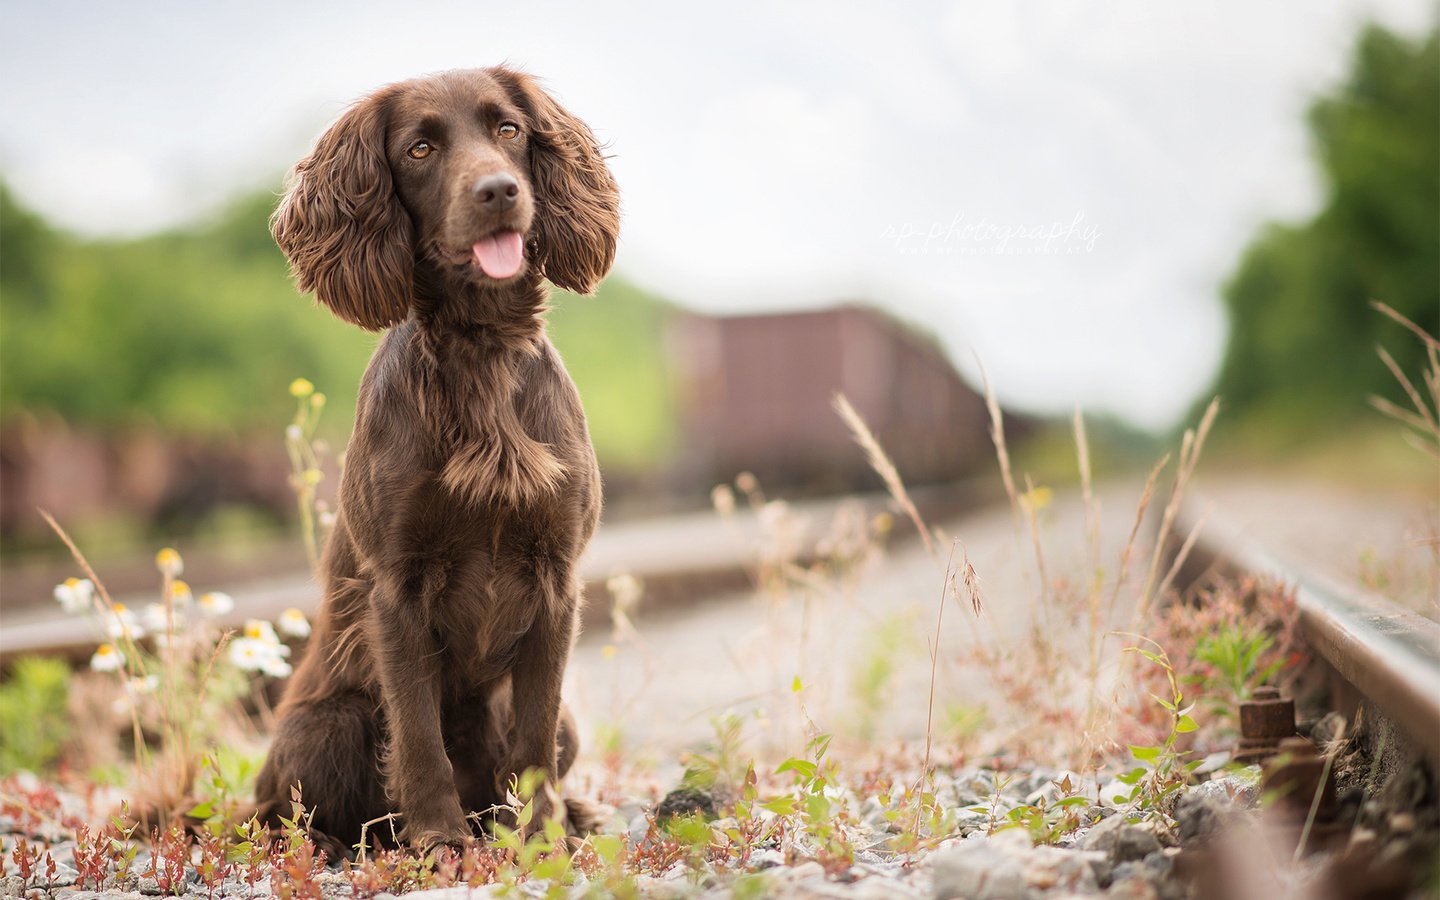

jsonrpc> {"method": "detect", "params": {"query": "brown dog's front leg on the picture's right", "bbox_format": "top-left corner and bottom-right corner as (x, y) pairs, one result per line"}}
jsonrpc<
(498, 576), (579, 825)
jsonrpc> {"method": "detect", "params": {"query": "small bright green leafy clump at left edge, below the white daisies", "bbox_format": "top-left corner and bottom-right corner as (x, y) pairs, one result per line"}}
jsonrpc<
(0, 657), (71, 775)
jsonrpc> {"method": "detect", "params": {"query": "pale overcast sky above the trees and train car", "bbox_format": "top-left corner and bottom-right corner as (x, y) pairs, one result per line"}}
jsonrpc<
(0, 0), (1433, 426)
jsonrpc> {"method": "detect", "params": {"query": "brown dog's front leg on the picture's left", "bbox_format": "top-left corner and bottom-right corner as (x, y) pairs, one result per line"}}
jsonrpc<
(370, 583), (471, 850)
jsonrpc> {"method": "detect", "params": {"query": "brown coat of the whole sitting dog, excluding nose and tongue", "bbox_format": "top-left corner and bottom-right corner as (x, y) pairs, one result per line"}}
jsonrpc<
(256, 68), (619, 851)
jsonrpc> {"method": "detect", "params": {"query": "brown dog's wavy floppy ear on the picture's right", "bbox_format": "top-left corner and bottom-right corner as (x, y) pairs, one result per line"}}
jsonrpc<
(494, 69), (621, 294)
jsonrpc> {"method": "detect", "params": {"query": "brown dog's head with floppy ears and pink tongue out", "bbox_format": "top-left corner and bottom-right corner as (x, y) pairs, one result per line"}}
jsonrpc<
(271, 68), (619, 330)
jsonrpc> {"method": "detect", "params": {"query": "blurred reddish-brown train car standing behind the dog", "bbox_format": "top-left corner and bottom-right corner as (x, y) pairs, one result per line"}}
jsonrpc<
(671, 305), (994, 492)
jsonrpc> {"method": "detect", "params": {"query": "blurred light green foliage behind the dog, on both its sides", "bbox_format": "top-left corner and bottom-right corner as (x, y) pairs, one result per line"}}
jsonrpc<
(0, 183), (674, 468)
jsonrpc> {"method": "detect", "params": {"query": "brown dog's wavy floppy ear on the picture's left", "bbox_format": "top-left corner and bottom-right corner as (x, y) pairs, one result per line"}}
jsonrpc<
(271, 94), (415, 331)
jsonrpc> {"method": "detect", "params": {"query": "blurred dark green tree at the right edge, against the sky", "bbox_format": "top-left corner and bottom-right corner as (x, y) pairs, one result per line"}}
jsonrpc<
(1217, 26), (1440, 433)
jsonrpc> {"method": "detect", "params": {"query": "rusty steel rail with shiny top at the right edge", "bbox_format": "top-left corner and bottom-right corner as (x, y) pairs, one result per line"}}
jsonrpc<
(1175, 503), (1440, 772)
